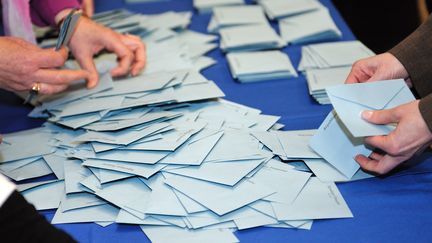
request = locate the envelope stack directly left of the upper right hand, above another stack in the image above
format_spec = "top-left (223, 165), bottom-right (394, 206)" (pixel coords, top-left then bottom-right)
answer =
top-left (298, 41), bottom-right (375, 71)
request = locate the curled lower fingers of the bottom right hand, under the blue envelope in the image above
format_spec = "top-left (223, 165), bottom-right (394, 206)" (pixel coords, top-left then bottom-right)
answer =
top-left (355, 155), bottom-right (403, 175)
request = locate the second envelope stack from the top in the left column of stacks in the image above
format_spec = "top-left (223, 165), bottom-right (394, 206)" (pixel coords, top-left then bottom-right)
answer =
top-left (207, 5), bottom-right (268, 33)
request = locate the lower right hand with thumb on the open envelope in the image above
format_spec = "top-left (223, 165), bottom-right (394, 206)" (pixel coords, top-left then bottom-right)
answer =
top-left (355, 100), bottom-right (432, 175)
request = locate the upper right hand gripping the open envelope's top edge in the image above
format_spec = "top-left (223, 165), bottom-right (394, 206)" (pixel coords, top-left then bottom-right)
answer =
top-left (345, 52), bottom-right (412, 87)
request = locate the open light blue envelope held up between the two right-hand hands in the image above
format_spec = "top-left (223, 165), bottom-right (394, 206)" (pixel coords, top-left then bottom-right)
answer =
top-left (326, 79), bottom-right (415, 137)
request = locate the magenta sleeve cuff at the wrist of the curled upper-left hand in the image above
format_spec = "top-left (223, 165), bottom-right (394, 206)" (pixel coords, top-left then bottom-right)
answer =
top-left (30, 0), bottom-right (81, 27)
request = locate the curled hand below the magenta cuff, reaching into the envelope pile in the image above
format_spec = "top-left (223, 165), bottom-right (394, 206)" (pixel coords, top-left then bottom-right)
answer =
top-left (69, 17), bottom-right (146, 88)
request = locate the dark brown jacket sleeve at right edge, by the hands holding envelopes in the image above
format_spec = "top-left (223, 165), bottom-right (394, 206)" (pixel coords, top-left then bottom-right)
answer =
top-left (389, 15), bottom-right (432, 131)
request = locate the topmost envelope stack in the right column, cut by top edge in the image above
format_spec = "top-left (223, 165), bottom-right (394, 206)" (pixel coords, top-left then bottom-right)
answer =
top-left (258, 0), bottom-right (325, 19)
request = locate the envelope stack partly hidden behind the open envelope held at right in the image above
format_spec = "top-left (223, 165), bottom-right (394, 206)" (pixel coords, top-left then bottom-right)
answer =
top-left (305, 66), bottom-right (351, 105)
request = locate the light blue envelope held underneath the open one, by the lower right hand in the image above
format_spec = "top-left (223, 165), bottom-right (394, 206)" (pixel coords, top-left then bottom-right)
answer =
top-left (309, 111), bottom-right (372, 178)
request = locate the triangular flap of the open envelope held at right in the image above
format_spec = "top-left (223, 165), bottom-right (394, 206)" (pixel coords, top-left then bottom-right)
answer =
top-left (326, 79), bottom-right (407, 110)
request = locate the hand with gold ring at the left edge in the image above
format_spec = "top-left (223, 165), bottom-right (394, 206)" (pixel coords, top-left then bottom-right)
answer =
top-left (0, 37), bottom-right (88, 94)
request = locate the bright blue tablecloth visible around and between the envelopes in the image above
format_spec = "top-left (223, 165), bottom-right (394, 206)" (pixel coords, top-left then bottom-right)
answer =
top-left (0, 0), bottom-right (432, 243)
